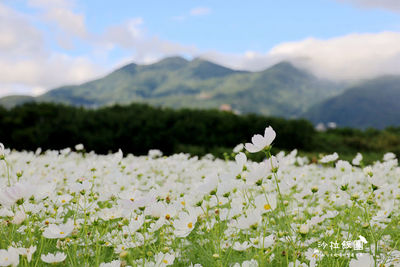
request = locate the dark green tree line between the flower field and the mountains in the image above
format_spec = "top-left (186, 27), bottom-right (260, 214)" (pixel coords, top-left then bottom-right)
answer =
top-left (0, 103), bottom-right (400, 159)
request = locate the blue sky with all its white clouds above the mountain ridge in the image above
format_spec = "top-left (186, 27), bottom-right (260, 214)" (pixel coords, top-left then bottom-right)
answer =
top-left (0, 0), bottom-right (400, 95)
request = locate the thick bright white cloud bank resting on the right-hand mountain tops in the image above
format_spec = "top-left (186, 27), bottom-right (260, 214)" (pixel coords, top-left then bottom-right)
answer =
top-left (269, 32), bottom-right (400, 79)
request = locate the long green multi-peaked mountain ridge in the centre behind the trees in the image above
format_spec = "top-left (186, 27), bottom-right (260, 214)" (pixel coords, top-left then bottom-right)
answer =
top-left (0, 57), bottom-right (343, 117)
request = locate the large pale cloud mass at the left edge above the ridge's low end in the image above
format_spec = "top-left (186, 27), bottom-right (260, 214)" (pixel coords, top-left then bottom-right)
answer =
top-left (0, 3), bottom-right (103, 98)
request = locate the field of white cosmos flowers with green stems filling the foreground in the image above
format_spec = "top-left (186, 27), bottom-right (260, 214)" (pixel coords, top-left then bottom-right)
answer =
top-left (0, 127), bottom-right (400, 267)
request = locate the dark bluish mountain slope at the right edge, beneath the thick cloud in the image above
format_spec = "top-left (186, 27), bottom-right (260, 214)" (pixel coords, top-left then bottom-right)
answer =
top-left (304, 76), bottom-right (400, 128)
